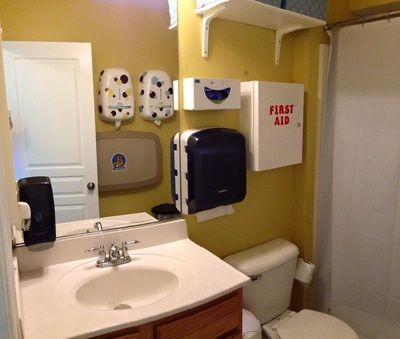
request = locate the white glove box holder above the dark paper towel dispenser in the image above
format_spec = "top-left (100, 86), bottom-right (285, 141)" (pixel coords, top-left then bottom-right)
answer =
top-left (183, 78), bottom-right (240, 111)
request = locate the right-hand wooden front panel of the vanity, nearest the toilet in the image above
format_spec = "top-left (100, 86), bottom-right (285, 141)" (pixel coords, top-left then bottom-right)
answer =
top-left (155, 293), bottom-right (242, 339)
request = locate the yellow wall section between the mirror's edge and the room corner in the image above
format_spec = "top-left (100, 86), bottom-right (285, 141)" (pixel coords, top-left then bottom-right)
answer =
top-left (178, 0), bottom-right (294, 257)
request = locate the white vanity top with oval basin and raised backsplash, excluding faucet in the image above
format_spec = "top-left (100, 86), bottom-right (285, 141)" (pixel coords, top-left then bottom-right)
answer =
top-left (15, 219), bottom-right (249, 339)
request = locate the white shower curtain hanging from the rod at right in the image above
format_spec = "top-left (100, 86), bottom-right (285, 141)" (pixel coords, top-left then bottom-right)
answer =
top-left (315, 18), bottom-right (400, 339)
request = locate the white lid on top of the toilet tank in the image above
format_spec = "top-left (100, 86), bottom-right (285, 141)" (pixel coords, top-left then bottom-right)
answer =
top-left (224, 238), bottom-right (299, 276)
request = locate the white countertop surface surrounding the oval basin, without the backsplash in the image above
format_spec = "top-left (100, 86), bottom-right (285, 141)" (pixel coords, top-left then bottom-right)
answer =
top-left (20, 221), bottom-right (249, 339)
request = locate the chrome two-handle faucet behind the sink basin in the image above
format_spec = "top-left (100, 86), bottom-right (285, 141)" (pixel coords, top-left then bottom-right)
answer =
top-left (85, 240), bottom-right (140, 268)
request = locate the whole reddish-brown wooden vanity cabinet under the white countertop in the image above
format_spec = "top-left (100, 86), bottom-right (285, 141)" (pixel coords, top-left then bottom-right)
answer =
top-left (94, 289), bottom-right (242, 339)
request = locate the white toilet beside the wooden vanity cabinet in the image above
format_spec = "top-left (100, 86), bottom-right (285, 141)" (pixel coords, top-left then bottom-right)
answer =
top-left (224, 238), bottom-right (358, 339)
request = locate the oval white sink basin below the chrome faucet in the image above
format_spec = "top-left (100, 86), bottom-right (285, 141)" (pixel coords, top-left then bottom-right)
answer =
top-left (75, 267), bottom-right (179, 310)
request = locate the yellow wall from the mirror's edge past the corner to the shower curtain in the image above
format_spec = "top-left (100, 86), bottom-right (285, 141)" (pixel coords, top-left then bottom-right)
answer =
top-left (179, 1), bottom-right (324, 266)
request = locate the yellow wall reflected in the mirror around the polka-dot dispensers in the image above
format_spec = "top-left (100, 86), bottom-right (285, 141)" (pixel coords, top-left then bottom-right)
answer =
top-left (0, 0), bottom-right (179, 244)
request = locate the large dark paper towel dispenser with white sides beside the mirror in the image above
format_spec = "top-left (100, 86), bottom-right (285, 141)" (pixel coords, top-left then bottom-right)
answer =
top-left (173, 128), bottom-right (246, 214)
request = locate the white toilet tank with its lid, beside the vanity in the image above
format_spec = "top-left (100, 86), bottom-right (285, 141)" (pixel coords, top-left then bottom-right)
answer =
top-left (224, 238), bottom-right (299, 324)
